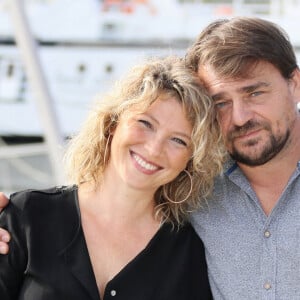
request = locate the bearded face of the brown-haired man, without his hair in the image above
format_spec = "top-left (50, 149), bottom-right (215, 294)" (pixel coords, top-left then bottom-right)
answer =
top-left (198, 61), bottom-right (299, 166)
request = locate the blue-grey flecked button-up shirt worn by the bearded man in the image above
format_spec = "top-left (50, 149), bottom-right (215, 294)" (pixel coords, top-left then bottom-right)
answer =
top-left (191, 162), bottom-right (300, 300)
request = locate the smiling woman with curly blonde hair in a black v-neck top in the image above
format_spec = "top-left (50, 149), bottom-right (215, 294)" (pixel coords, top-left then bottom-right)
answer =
top-left (0, 57), bottom-right (223, 300)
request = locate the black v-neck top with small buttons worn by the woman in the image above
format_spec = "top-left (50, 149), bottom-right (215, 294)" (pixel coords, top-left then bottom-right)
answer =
top-left (0, 186), bottom-right (212, 300)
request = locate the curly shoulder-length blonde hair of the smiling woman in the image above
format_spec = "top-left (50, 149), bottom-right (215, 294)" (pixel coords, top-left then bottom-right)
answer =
top-left (65, 56), bottom-right (226, 224)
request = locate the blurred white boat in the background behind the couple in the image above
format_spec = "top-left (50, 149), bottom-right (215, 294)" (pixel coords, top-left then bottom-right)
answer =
top-left (0, 0), bottom-right (300, 136)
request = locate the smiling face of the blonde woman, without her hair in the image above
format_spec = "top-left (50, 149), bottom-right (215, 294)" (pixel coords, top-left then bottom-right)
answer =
top-left (106, 97), bottom-right (192, 192)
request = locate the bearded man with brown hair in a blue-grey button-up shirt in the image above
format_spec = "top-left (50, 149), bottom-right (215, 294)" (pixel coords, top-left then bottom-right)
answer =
top-left (0, 17), bottom-right (300, 300)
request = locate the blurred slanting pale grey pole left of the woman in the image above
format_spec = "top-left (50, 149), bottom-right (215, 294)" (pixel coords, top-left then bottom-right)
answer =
top-left (8, 0), bottom-right (64, 184)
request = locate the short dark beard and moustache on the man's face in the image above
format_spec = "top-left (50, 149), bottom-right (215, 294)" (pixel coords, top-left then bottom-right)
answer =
top-left (228, 121), bottom-right (290, 167)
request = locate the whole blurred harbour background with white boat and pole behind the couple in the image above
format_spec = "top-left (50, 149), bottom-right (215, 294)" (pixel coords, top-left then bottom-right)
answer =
top-left (0, 0), bottom-right (300, 194)
